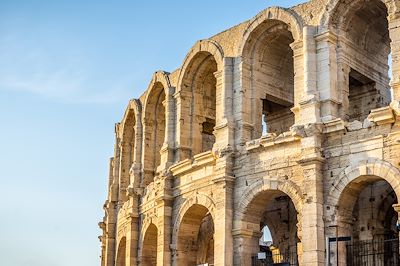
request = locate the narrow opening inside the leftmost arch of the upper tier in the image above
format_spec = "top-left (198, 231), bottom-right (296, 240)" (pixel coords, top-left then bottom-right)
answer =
top-left (119, 107), bottom-right (136, 202)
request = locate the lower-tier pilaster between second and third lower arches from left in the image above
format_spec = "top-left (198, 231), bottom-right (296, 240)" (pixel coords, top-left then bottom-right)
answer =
top-left (156, 176), bottom-right (173, 266)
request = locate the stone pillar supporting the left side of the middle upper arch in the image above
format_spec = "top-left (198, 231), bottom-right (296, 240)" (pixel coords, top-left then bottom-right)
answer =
top-left (174, 90), bottom-right (193, 161)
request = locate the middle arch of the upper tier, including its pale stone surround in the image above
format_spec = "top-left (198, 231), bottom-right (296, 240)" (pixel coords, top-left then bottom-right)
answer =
top-left (174, 40), bottom-right (224, 161)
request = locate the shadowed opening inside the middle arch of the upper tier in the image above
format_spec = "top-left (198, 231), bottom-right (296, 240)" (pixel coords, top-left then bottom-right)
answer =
top-left (181, 52), bottom-right (218, 156)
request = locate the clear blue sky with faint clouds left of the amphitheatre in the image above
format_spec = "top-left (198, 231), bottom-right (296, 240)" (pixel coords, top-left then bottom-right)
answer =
top-left (0, 0), bottom-right (301, 266)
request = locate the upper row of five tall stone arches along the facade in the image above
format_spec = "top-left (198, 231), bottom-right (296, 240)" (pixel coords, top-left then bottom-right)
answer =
top-left (115, 0), bottom-right (392, 200)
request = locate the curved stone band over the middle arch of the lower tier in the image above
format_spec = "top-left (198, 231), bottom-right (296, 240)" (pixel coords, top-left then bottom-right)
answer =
top-left (172, 194), bottom-right (215, 246)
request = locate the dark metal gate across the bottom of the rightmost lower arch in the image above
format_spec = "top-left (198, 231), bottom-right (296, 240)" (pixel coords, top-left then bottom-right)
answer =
top-left (346, 239), bottom-right (400, 266)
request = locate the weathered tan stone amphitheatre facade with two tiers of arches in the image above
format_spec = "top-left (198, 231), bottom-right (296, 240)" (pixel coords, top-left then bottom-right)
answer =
top-left (99, 0), bottom-right (400, 266)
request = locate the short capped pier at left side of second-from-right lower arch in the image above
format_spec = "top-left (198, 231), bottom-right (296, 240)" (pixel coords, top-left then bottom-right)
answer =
top-left (231, 229), bottom-right (262, 266)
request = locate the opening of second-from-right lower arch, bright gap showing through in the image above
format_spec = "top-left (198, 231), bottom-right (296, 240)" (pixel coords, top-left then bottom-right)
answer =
top-left (234, 190), bottom-right (300, 265)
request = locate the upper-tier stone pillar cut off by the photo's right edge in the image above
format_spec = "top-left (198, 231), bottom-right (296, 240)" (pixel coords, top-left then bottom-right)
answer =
top-left (388, 8), bottom-right (400, 104)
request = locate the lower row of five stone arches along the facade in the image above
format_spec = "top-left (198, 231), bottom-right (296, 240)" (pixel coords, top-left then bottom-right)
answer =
top-left (117, 160), bottom-right (400, 266)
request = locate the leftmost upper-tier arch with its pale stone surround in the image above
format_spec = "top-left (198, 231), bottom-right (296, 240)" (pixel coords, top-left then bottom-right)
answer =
top-left (118, 99), bottom-right (142, 201)
